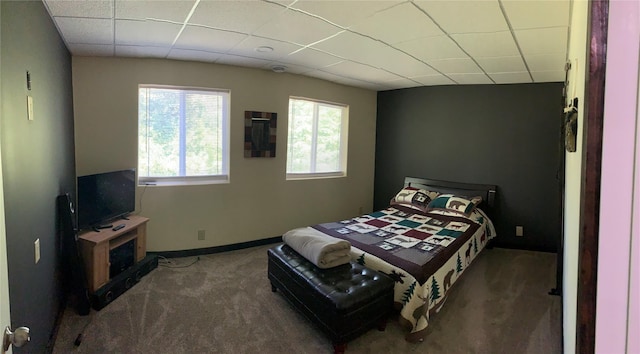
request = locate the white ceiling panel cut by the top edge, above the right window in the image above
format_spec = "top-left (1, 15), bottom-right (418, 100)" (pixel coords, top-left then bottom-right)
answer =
top-left (291, 0), bottom-right (402, 28)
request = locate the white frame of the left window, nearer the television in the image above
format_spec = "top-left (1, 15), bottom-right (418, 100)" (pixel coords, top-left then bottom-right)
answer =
top-left (137, 84), bottom-right (231, 186)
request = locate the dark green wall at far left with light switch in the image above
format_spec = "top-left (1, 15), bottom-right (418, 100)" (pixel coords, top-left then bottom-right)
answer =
top-left (0, 1), bottom-right (75, 353)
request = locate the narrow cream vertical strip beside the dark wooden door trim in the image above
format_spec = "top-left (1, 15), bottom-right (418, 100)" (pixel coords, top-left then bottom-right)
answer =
top-left (562, 0), bottom-right (589, 354)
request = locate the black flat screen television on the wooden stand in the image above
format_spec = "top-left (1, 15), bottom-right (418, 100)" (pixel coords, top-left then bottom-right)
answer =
top-left (77, 169), bottom-right (136, 229)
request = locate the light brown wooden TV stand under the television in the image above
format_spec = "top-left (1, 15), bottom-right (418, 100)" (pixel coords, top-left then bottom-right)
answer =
top-left (78, 215), bottom-right (149, 293)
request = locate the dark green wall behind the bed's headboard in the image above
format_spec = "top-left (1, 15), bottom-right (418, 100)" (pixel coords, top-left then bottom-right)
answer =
top-left (374, 83), bottom-right (562, 251)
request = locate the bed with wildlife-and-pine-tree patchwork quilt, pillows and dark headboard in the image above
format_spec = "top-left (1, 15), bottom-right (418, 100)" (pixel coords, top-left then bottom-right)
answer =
top-left (283, 177), bottom-right (496, 342)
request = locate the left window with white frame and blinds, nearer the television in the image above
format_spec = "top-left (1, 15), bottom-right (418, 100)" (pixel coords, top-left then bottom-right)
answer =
top-left (138, 85), bottom-right (229, 184)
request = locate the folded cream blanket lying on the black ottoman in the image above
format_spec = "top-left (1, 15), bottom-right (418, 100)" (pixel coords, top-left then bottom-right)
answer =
top-left (282, 227), bottom-right (351, 268)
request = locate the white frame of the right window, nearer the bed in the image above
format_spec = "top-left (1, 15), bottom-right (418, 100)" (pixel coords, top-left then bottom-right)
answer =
top-left (285, 96), bottom-right (349, 180)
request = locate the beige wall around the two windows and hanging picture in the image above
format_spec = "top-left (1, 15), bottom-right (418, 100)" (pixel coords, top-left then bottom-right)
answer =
top-left (73, 57), bottom-right (377, 251)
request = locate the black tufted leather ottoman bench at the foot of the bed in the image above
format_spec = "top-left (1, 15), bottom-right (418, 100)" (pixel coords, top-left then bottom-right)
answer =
top-left (267, 244), bottom-right (394, 353)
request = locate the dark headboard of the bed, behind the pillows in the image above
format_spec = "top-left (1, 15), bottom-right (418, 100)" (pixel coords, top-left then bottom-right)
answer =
top-left (404, 177), bottom-right (497, 211)
